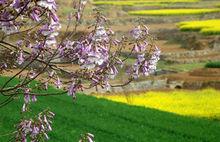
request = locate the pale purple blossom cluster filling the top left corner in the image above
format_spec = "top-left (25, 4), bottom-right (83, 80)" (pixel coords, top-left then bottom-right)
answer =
top-left (0, 0), bottom-right (60, 46)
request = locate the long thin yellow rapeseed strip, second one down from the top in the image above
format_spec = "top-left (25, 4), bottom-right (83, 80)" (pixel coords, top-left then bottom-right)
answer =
top-left (128, 8), bottom-right (220, 16)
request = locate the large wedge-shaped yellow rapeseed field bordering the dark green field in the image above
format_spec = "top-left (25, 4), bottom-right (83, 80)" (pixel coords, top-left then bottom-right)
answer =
top-left (97, 89), bottom-right (220, 118)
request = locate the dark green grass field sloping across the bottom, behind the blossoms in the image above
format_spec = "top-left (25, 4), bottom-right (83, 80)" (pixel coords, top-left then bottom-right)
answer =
top-left (0, 78), bottom-right (220, 142)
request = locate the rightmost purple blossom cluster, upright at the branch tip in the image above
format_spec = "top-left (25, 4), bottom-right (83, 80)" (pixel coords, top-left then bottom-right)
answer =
top-left (128, 25), bottom-right (160, 79)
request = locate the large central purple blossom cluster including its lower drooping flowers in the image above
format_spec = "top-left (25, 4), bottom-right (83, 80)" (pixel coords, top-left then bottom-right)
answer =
top-left (59, 17), bottom-right (123, 91)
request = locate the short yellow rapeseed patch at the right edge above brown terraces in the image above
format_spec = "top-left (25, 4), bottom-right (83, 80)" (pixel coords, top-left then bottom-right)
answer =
top-left (177, 19), bottom-right (220, 34)
